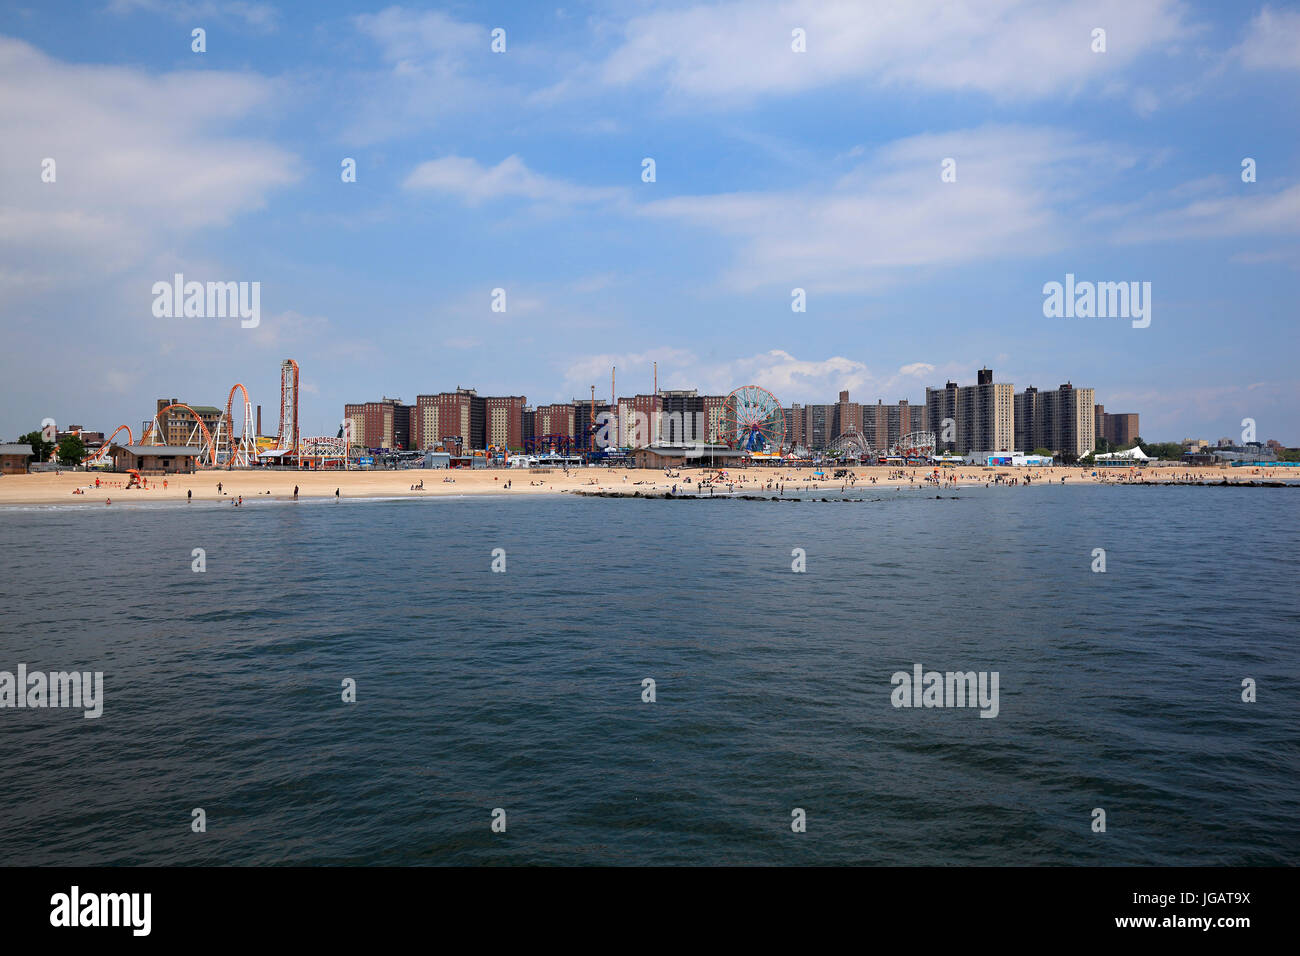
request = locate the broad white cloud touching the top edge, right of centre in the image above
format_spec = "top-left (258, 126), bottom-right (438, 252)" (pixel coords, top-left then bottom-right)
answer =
top-left (599, 0), bottom-right (1191, 100)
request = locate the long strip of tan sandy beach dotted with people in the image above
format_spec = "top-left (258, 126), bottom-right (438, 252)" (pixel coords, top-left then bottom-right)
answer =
top-left (0, 466), bottom-right (1300, 506)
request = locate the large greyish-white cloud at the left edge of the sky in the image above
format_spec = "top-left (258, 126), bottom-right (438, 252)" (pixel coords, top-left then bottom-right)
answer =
top-left (0, 38), bottom-right (299, 297)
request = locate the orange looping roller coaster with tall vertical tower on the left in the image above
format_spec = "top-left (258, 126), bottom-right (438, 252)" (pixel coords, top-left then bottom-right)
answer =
top-left (82, 359), bottom-right (351, 468)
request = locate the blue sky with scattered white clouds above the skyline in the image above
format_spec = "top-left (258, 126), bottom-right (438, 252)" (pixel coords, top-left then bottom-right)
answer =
top-left (0, 0), bottom-right (1300, 445)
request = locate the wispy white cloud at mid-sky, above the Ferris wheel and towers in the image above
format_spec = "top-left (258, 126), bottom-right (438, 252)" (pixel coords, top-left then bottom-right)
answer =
top-left (640, 127), bottom-right (1134, 297)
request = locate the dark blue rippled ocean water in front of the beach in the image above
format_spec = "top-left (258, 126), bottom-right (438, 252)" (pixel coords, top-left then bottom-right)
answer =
top-left (0, 485), bottom-right (1300, 865)
